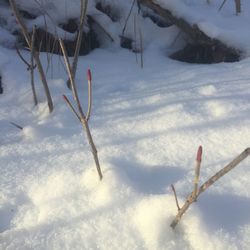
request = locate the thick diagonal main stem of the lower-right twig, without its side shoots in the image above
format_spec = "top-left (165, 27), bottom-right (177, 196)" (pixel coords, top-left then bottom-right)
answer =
top-left (170, 148), bottom-right (250, 229)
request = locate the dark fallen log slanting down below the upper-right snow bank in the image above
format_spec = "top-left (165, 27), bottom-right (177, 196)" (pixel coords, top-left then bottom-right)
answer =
top-left (138, 0), bottom-right (241, 63)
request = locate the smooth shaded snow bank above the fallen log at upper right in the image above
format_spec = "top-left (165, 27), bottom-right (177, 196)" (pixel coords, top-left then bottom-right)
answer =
top-left (154, 0), bottom-right (250, 55)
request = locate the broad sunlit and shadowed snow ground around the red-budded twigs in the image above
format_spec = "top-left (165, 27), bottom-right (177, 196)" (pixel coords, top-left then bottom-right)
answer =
top-left (0, 0), bottom-right (250, 250)
